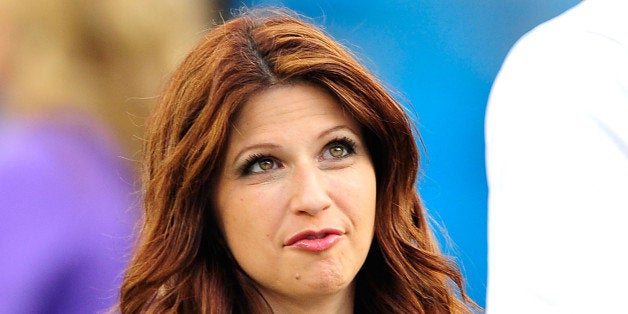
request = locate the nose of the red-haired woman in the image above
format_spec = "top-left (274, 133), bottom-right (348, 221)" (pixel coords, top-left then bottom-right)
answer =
top-left (290, 165), bottom-right (332, 215)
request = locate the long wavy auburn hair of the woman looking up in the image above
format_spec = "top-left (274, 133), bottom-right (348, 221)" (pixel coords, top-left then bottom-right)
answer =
top-left (120, 10), bottom-right (473, 313)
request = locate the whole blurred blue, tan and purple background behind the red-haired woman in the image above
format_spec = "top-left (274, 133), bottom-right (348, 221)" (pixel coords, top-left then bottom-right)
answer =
top-left (0, 0), bottom-right (578, 313)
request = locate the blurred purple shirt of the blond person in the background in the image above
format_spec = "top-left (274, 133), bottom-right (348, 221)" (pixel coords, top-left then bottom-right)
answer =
top-left (0, 114), bottom-right (138, 313)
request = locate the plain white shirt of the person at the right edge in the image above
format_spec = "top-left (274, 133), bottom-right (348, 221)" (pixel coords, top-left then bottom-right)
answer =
top-left (485, 0), bottom-right (628, 314)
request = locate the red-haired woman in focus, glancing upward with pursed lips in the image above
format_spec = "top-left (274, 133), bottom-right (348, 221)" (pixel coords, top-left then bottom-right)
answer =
top-left (120, 7), bottom-right (473, 313)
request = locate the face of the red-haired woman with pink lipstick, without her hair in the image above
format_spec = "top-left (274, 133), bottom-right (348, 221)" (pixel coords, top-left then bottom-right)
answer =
top-left (215, 84), bottom-right (376, 306)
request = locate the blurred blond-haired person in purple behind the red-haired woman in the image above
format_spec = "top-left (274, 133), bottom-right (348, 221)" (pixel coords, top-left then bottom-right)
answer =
top-left (0, 0), bottom-right (216, 313)
